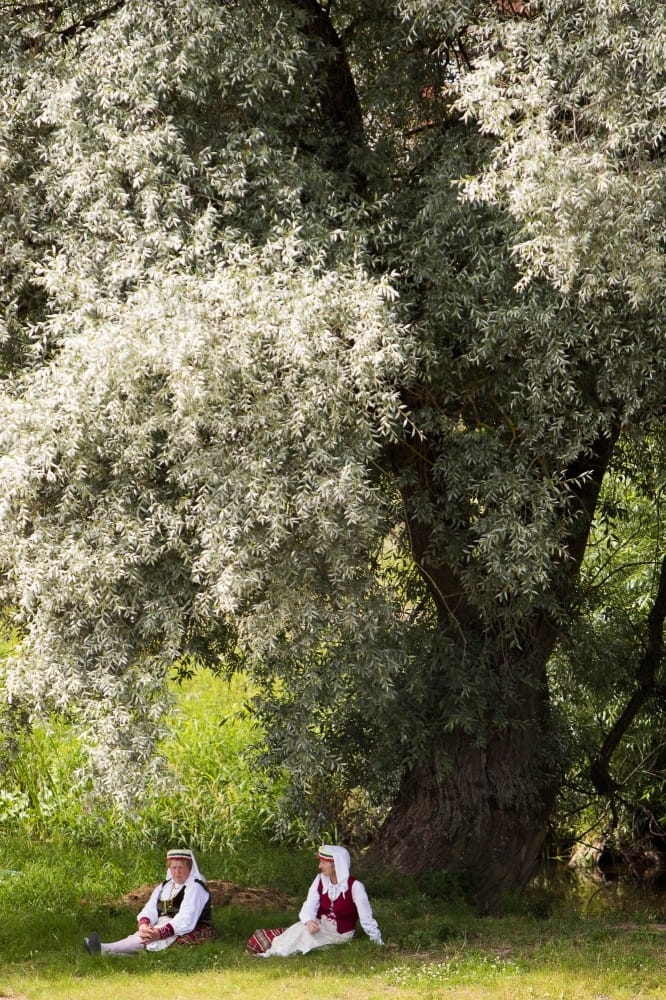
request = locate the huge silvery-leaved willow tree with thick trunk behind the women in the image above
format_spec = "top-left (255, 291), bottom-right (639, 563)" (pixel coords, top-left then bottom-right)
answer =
top-left (0, 0), bottom-right (666, 907)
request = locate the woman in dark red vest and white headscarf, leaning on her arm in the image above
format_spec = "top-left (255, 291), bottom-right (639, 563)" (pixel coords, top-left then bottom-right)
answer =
top-left (247, 844), bottom-right (383, 958)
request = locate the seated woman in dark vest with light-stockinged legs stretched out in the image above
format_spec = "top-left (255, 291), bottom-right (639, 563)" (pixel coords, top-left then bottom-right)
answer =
top-left (84, 849), bottom-right (215, 955)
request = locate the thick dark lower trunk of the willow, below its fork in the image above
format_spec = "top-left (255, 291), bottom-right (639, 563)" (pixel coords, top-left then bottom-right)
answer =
top-left (370, 644), bottom-right (559, 913)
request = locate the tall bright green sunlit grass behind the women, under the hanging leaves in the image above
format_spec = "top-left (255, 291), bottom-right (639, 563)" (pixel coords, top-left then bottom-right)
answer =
top-left (0, 671), bottom-right (281, 851)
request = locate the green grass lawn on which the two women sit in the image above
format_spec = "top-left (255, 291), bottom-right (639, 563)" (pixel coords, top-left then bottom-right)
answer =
top-left (0, 844), bottom-right (666, 1000)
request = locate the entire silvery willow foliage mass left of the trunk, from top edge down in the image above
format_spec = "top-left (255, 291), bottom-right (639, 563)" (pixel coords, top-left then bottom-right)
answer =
top-left (0, 2), bottom-right (410, 785)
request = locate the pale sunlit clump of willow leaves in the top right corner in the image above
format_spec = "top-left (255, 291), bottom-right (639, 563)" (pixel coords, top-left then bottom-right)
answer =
top-left (462, 0), bottom-right (666, 304)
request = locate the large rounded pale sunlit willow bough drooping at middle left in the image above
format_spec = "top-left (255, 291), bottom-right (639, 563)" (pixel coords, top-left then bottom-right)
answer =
top-left (0, 261), bottom-right (412, 796)
